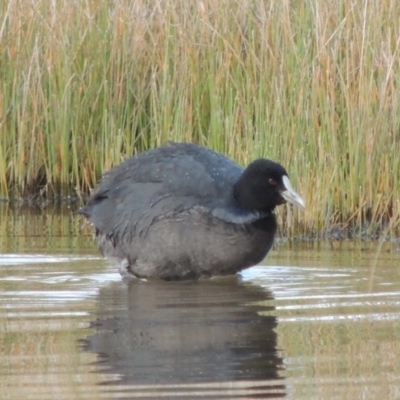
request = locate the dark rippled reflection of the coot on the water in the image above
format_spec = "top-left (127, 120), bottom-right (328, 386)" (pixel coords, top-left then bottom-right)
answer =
top-left (83, 277), bottom-right (284, 397)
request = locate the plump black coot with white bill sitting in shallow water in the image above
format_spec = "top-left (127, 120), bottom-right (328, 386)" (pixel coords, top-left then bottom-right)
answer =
top-left (78, 143), bottom-right (305, 279)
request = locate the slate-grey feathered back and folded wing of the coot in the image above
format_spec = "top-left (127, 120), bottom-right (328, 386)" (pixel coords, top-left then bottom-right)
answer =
top-left (80, 143), bottom-right (243, 239)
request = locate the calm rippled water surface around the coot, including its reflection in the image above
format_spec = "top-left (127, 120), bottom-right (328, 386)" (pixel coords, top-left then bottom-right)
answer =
top-left (0, 207), bottom-right (400, 400)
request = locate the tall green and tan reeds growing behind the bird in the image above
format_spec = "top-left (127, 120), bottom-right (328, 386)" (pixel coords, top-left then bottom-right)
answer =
top-left (0, 0), bottom-right (400, 239)
